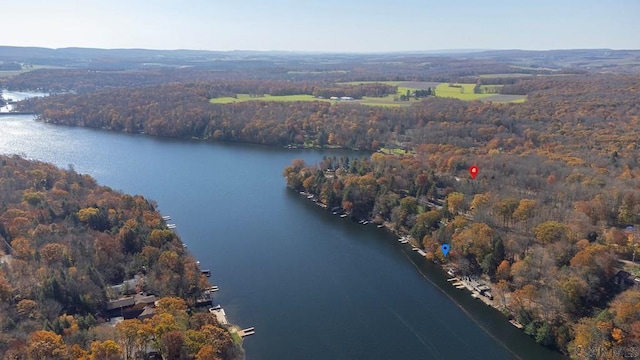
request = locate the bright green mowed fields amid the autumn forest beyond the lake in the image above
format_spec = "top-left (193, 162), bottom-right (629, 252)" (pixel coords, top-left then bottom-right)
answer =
top-left (209, 81), bottom-right (526, 106)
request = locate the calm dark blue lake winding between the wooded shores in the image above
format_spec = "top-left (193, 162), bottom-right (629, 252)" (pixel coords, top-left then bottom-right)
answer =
top-left (0, 116), bottom-right (559, 359)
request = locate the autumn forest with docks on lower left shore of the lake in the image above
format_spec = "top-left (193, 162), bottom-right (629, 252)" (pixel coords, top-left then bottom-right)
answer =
top-left (0, 155), bottom-right (242, 360)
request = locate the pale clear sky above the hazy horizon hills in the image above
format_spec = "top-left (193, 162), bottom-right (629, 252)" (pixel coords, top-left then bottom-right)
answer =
top-left (0, 0), bottom-right (640, 52)
